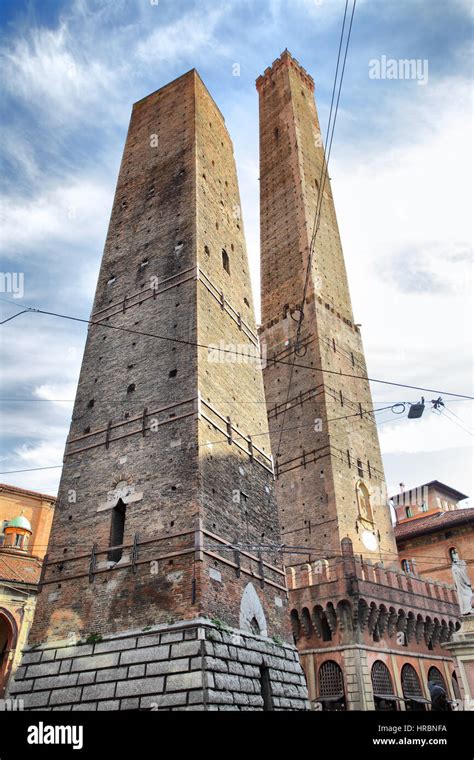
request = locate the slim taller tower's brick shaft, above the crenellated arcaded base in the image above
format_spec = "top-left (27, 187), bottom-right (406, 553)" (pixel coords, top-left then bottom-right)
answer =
top-left (257, 51), bottom-right (397, 562)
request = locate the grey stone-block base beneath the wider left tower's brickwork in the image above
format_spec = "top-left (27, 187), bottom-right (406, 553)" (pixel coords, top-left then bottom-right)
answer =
top-left (9, 618), bottom-right (309, 710)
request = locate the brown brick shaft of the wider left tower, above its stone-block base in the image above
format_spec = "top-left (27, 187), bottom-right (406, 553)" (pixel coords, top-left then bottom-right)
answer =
top-left (24, 65), bottom-right (290, 656)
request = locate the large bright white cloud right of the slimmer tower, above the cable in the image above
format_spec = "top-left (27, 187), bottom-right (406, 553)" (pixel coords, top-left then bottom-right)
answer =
top-left (331, 79), bottom-right (472, 410)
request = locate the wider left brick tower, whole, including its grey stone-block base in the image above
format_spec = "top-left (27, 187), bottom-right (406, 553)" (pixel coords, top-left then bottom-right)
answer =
top-left (11, 70), bottom-right (307, 710)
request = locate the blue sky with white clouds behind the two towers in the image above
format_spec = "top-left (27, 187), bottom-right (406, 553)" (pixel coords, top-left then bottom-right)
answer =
top-left (0, 0), bottom-right (473, 503)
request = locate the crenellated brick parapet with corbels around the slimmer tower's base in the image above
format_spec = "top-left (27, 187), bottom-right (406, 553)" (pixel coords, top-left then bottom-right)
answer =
top-left (287, 539), bottom-right (459, 646)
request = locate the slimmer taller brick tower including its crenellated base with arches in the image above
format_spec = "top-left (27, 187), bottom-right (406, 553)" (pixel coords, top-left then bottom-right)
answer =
top-left (257, 51), bottom-right (457, 710)
